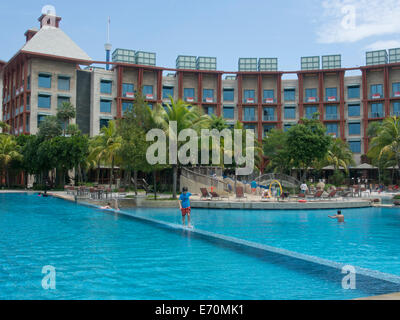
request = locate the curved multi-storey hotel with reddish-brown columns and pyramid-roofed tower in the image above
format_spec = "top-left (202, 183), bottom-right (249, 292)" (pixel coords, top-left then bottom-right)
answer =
top-left (0, 9), bottom-right (400, 163)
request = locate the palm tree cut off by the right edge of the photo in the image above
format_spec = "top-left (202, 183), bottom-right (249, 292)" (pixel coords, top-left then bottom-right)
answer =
top-left (368, 116), bottom-right (400, 175)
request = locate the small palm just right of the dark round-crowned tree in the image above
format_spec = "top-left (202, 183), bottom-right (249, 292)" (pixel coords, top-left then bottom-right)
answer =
top-left (325, 139), bottom-right (354, 173)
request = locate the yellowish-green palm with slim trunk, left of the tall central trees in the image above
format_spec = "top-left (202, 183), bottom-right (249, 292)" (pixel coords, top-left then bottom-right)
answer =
top-left (88, 121), bottom-right (122, 188)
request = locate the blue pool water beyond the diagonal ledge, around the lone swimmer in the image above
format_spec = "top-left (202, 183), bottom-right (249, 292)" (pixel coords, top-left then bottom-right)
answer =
top-left (130, 208), bottom-right (400, 276)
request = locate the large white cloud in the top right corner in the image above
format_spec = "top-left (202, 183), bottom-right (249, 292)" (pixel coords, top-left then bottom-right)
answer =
top-left (317, 0), bottom-right (400, 43)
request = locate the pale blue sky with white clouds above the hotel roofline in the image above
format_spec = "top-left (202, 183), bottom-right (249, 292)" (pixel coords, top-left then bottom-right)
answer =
top-left (0, 0), bottom-right (400, 77)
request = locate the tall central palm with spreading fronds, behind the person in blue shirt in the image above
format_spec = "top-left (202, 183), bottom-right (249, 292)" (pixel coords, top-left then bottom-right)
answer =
top-left (152, 98), bottom-right (209, 198)
